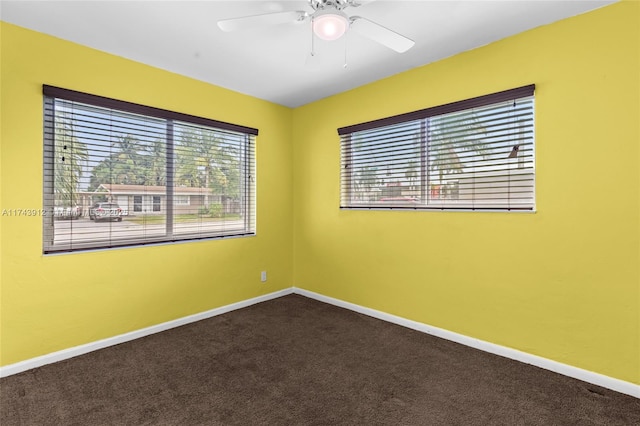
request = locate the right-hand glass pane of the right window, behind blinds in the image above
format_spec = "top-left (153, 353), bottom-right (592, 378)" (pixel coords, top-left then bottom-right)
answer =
top-left (428, 99), bottom-right (535, 208)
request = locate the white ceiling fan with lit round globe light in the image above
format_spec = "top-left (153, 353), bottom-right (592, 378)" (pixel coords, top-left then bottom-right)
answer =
top-left (218, 0), bottom-right (415, 53)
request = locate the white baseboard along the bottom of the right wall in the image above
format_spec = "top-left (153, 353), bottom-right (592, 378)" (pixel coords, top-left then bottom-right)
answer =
top-left (293, 287), bottom-right (640, 398)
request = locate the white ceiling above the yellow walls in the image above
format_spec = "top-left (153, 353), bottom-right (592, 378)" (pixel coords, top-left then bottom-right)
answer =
top-left (0, 0), bottom-right (617, 107)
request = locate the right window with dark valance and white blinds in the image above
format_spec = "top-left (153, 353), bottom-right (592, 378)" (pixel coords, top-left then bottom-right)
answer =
top-left (338, 85), bottom-right (535, 211)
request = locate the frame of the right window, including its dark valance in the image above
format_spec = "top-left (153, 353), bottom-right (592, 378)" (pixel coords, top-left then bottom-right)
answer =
top-left (337, 84), bottom-right (536, 212)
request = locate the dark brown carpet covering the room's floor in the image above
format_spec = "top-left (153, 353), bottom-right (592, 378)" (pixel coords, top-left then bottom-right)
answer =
top-left (0, 295), bottom-right (640, 426)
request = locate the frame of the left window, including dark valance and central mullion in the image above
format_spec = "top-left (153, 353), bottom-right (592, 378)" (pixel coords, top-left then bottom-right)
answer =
top-left (42, 84), bottom-right (258, 254)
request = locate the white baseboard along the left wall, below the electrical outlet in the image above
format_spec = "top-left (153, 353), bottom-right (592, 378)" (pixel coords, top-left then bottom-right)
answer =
top-left (0, 288), bottom-right (293, 377)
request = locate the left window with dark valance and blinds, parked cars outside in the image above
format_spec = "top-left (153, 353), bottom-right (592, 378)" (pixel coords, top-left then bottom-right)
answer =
top-left (43, 86), bottom-right (258, 253)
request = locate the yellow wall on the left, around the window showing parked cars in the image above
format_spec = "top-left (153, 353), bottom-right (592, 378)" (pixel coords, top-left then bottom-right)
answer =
top-left (0, 23), bottom-right (293, 365)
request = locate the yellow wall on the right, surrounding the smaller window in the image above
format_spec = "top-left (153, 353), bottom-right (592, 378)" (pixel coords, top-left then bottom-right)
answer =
top-left (293, 2), bottom-right (640, 383)
